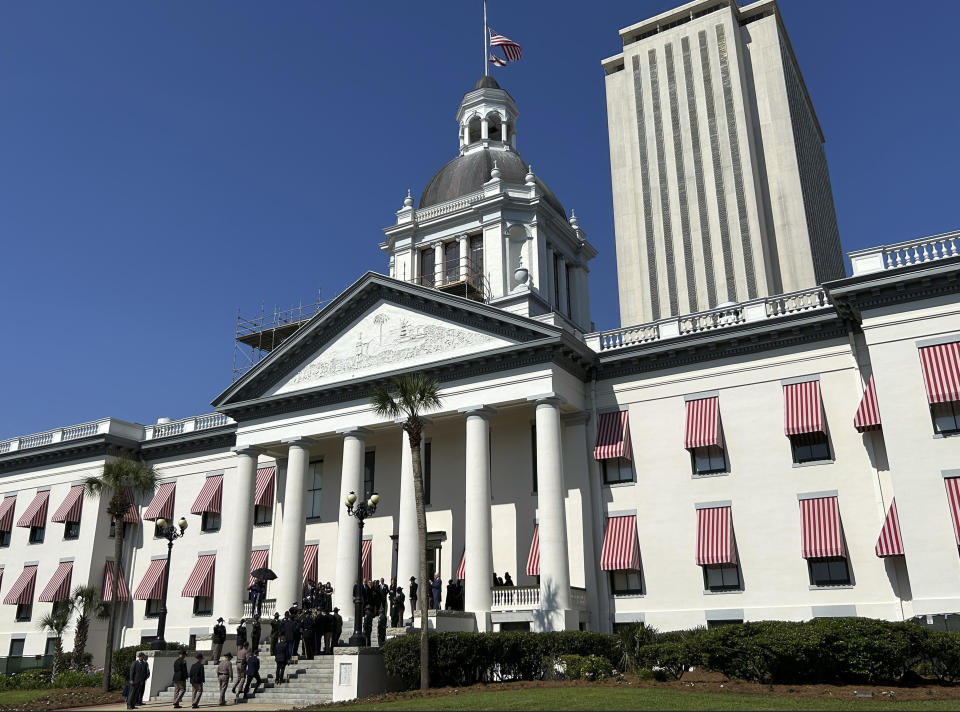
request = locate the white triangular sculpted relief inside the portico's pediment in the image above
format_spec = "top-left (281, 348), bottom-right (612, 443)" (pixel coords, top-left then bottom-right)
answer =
top-left (269, 301), bottom-right (516, 395)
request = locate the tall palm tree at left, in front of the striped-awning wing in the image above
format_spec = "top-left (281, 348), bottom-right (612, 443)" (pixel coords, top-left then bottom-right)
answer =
top-left (84, 458), bottom-right (157, 692)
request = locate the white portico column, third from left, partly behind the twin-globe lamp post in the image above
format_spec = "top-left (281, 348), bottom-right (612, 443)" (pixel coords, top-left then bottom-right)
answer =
top-left (333, 428), bottom-right (368, 616)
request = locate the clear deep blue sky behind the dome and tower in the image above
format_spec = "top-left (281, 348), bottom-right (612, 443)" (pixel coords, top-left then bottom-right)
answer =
top-left (0, 0), bottom-right (960, 439)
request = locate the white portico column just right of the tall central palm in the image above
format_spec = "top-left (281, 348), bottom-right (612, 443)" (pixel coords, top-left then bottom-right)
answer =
top-left (460, 407), bottom-right (493, 629)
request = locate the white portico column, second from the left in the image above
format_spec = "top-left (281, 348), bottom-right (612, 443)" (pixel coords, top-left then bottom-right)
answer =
top-left (274, 439), bottom-right (310, 612)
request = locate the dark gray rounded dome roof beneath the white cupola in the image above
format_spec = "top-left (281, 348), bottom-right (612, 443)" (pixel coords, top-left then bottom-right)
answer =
top-left (419, 148), bottom-right (567, 216)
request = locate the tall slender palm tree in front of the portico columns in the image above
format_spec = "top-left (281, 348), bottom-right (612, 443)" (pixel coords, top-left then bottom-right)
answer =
top-left (372, 373), bottom-right (440, 690)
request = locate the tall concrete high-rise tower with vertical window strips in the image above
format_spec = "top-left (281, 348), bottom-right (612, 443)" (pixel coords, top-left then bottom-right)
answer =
top-left (603, 0), bottom-right (844, 325)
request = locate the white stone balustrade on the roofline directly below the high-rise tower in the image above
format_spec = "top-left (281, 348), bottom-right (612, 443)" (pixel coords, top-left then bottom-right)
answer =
top-left (584, 287), bottom-right (831, 351)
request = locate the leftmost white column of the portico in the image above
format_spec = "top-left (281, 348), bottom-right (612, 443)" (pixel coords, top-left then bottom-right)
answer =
top-left (217, 447), bottom-right (260, 620)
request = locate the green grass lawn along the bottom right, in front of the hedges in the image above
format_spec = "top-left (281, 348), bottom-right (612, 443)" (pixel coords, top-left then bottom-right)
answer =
top-left (351, 685), bottom-right (958, 710)
